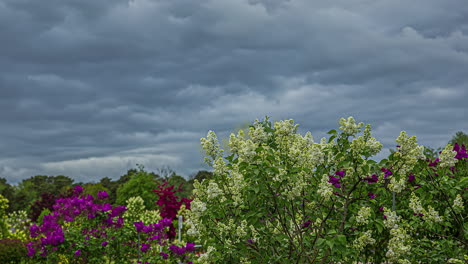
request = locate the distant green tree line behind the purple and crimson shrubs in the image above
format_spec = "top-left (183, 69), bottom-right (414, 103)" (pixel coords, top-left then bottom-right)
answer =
top-left (0, 165), bottom-right (212, 222)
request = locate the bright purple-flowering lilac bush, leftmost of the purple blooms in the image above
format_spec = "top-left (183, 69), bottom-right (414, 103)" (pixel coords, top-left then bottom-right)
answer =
top-left (27, 186), bottom-right (129, 263)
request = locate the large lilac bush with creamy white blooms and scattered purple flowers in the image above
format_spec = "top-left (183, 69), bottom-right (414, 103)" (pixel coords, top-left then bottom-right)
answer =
top-left (188, 117), bottom-right (468, 263)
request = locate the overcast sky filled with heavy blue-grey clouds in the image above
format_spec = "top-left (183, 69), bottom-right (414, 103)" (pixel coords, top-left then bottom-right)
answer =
top-left (0, 0), bottom-right (468, 183)
